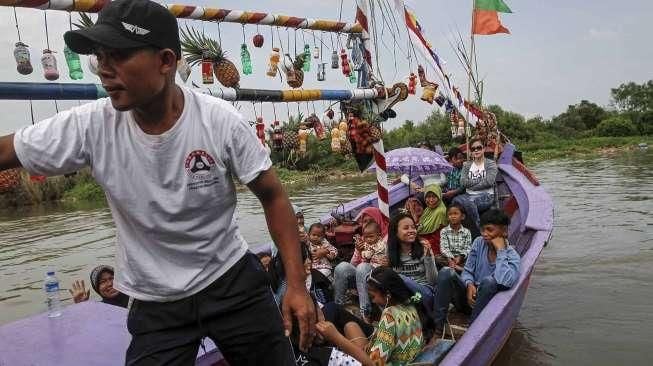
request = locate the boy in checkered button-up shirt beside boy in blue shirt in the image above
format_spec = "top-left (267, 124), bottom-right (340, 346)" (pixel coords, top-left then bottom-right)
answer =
top-left (440, 203), bottom-right (472, 273)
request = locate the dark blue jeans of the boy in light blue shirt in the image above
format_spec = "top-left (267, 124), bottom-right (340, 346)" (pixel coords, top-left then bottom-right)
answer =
top-left (435, 267), bottom-right (503, 329)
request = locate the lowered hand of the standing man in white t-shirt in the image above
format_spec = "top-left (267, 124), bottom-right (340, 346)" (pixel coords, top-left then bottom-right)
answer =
top-left (282, 287), bottom-right (315, 352)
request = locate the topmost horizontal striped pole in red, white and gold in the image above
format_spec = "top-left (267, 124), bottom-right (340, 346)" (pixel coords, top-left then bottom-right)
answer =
top-left (0, 0), bottom-right (362, 33)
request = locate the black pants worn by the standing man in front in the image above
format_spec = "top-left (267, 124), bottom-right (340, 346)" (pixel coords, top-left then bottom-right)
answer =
top-left (126, 253), bottom-right (295, 366)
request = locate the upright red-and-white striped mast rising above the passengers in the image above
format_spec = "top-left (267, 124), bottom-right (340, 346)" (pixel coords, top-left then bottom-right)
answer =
top-left (356, 0), bottom-right (390, 220)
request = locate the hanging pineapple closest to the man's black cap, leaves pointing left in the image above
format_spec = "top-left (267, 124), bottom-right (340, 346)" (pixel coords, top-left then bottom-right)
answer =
top-left (181, 26), bottom-right (240, 88)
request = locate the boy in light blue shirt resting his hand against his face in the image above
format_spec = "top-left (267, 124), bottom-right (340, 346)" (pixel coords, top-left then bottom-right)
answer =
top-left (435, 209), bottom-right (520, 331)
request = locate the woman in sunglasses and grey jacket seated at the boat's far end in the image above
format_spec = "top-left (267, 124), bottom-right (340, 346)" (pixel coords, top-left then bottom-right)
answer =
top-left (453, 138), bottom-right (499, 233)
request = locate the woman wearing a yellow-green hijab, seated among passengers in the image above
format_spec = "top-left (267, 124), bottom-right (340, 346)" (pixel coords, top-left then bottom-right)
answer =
top-left (417, 184), bottom-right (448, 256)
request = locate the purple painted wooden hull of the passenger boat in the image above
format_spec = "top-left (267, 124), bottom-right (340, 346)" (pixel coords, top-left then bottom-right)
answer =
top-left (0, 145), bottom-right (553, 366)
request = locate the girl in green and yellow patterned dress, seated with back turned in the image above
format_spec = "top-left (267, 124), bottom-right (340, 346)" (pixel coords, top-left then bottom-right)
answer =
top-left (315, 267), bottom-right (431, 366)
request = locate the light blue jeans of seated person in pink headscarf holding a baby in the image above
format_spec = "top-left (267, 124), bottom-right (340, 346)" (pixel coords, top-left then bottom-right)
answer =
top-left (333, 262), bottom-right (372, 316)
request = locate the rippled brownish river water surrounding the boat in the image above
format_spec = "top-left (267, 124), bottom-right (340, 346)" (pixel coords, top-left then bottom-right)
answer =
top-left (0, 151), bottom-right (653, 366)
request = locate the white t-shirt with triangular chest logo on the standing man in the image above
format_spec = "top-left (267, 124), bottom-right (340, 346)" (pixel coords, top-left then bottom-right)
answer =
top-left (14, 87), bottom-right (272, 301)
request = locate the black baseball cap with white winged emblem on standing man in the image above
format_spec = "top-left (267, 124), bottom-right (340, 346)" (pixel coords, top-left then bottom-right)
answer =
top-left (64, 0), bottom-right (181, 59)
